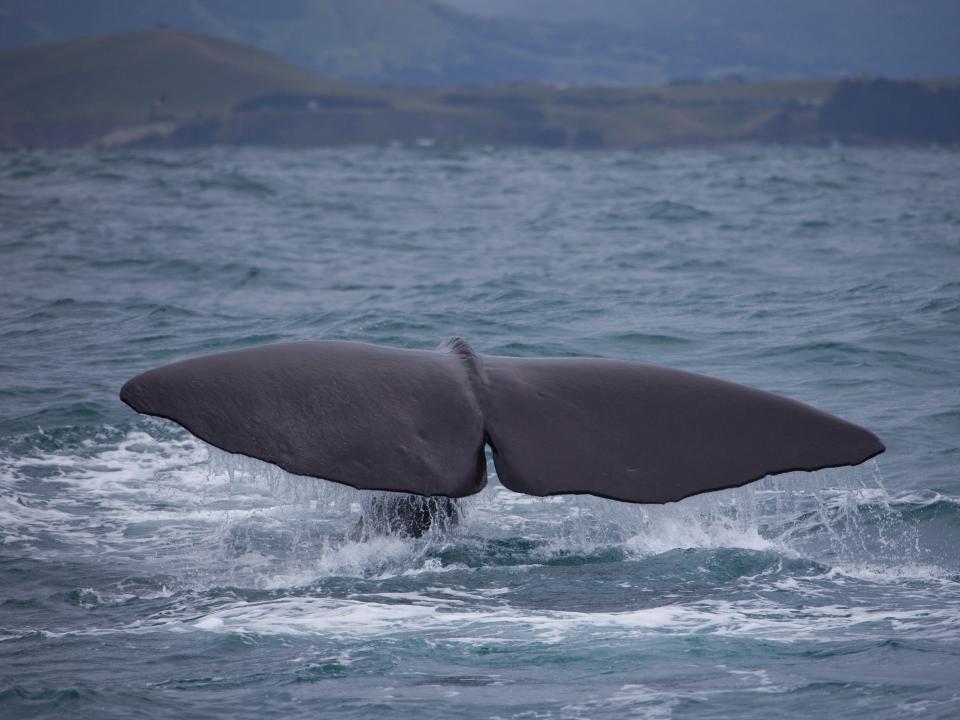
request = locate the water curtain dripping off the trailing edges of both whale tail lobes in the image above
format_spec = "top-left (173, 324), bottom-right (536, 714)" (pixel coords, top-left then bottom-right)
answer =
top-left (202, 438), bottom-right (924, 572)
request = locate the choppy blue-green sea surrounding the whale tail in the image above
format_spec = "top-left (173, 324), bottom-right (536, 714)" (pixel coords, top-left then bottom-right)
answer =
top-left (0, 147), bottom-right (960, 720)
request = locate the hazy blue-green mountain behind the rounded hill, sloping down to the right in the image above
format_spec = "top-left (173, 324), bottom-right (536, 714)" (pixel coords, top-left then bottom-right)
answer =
top-left (0, 0), bottom-right (664, 85)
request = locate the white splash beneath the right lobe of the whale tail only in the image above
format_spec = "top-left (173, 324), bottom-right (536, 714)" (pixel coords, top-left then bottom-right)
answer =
top-left (460, 462), bottom-right (943, 576)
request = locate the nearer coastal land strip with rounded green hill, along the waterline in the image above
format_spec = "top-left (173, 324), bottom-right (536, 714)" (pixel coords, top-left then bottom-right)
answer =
top-left (0, 29), bottom-right (955, 148)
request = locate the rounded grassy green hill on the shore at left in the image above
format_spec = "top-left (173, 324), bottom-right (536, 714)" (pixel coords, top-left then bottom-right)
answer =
top-left (0, 30), bottom-right (362, 121)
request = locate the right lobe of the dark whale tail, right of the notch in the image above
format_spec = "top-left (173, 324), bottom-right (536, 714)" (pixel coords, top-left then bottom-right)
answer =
top-left (484, 357), bottom-right (884, 503)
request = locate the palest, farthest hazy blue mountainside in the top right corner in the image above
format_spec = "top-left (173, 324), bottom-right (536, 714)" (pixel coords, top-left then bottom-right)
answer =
top-left (440, 0), bottom-right (960, 78)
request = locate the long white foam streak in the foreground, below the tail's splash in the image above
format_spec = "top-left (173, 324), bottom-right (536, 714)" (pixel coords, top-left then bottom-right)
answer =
top-left (172, 593), bottom-right (960, 644)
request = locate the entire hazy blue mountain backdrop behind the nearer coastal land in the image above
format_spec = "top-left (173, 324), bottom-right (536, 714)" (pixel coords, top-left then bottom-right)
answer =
top-left (0, 0), bottom-right (960, 85)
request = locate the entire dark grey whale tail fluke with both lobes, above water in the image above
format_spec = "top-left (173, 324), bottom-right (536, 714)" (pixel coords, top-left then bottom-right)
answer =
top-left (120, 338), bottom-right (884, 503)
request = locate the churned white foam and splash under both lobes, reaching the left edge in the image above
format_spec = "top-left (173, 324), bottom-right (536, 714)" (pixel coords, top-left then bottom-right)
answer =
top-left (0, 431), bottom-right (952, 589)
